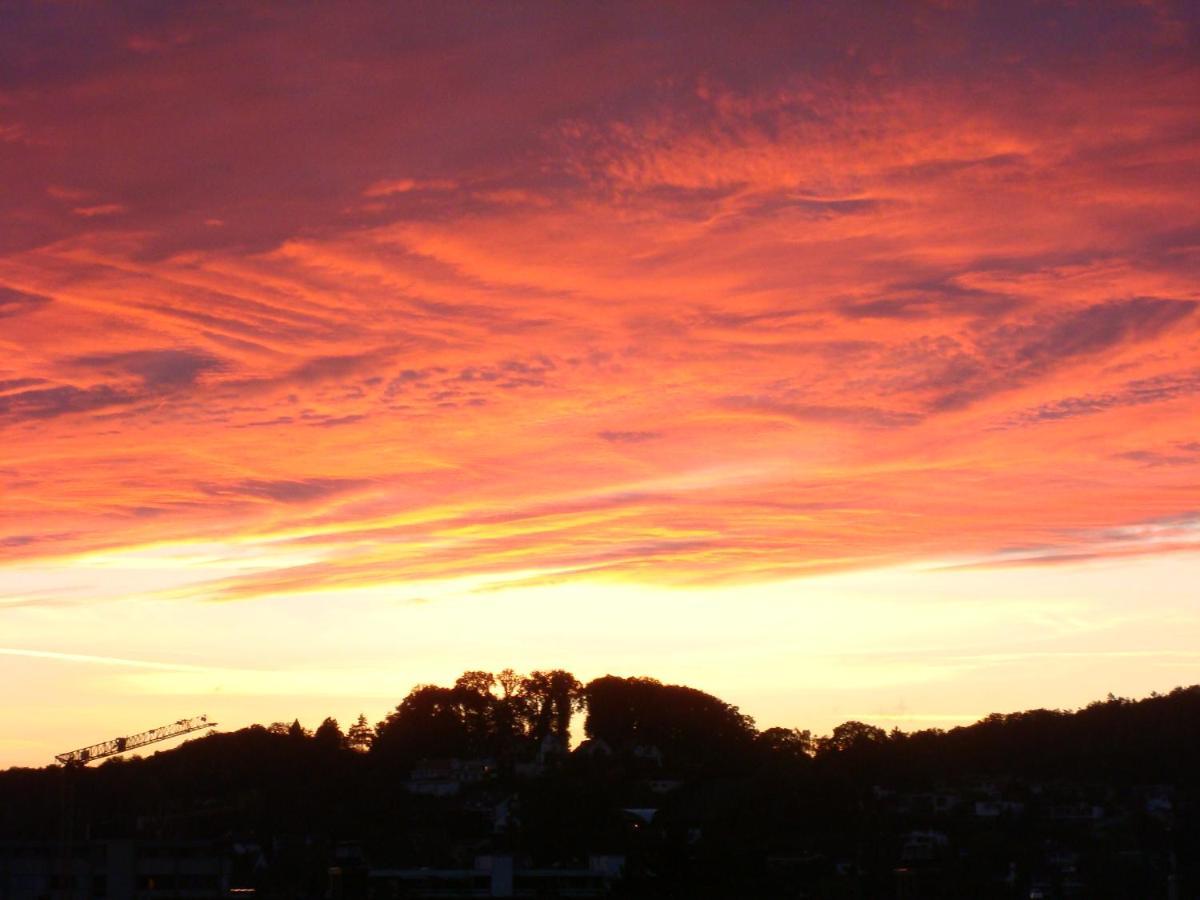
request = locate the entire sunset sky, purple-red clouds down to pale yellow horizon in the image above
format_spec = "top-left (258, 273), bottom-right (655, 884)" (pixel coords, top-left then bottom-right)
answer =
top-left (0, 0), bottom-right (1200, 766)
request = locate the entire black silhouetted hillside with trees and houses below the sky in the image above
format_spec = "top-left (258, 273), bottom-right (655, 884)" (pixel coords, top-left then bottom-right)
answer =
top-left (0, 671), bottom-right (1200, 900)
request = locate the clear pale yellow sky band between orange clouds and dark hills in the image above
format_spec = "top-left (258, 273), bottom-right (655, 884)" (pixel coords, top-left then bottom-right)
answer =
top-left (0, 556), bottom-right (1200, 766)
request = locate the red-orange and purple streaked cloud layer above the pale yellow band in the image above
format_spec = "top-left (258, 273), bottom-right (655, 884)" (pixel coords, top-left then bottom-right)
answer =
top-left (0, 4), bottom-right (1200, 607)
